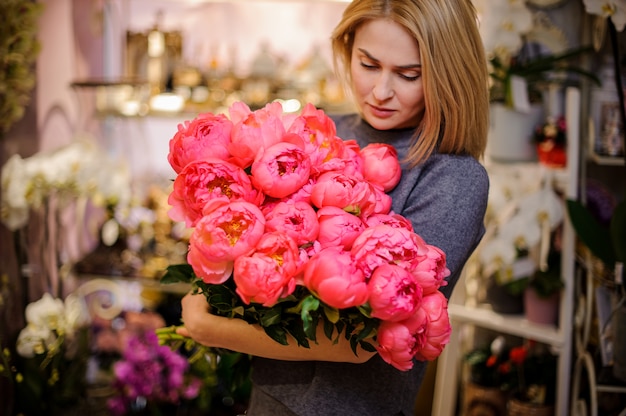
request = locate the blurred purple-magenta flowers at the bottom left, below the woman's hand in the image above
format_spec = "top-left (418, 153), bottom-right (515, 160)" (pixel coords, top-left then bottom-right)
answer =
top-left (107, 332), bottom-right (202, 415)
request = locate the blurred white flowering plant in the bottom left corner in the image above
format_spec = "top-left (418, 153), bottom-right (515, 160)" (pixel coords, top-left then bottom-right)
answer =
top-left (0, 293), bottom-right (90, 414)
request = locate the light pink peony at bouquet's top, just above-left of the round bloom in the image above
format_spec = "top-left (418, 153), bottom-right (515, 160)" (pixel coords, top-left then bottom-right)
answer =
top-left (228, 101), bottom-right (286, 168)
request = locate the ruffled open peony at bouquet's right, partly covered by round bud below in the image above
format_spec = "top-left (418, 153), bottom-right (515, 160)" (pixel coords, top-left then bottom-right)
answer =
top-left (351, 224), bottom-right (428, 278)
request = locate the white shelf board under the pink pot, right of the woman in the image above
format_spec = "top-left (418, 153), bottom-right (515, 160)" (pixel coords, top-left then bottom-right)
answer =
top-left (448, 304), bottom-right (564, 348)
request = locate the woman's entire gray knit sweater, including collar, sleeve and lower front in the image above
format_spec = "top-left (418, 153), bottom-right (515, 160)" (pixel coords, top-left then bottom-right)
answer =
top-left (248, 114), bottom-right (489, 416)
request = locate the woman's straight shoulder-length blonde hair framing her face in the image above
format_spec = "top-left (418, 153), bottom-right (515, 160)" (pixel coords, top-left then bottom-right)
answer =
top-left (331, 0), bottom-right (489, 165)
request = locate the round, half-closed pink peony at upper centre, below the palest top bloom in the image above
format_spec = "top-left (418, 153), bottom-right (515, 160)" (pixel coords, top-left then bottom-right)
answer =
top-left (252, 142), bottom-right (311, 198)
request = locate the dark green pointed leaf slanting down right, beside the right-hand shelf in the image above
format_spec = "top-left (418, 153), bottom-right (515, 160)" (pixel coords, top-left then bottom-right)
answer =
top-left (566, 199), bottom-right (615, 270)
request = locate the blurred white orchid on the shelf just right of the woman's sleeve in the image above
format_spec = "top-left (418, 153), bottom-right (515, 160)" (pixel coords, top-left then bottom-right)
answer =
top-left (475, 165), bottom-right (565, 298)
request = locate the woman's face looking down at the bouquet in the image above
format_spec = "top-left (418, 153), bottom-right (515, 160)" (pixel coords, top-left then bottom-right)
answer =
top-left (350, 19), bottom-right (424, 130)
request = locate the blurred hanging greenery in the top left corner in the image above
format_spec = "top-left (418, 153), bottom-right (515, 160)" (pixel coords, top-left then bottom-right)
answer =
top-left (0, 0), bottom-right (43, 134)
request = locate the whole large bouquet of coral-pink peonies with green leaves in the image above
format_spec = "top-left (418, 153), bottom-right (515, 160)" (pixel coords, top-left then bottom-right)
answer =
top-left (163, 102), bottom-right (451, 370)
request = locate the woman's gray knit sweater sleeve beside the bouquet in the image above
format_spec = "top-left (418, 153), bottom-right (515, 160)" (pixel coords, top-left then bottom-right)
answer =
top-left (400, 155), bottom-right (489, 298)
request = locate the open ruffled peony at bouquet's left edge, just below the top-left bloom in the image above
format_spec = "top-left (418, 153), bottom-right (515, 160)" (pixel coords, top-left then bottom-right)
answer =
top-left (168, 158), bottom-right (263, 227)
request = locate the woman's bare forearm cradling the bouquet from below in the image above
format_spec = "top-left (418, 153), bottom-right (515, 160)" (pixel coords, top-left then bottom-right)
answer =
top-left (177, 294), bottom-right (376, 363)
